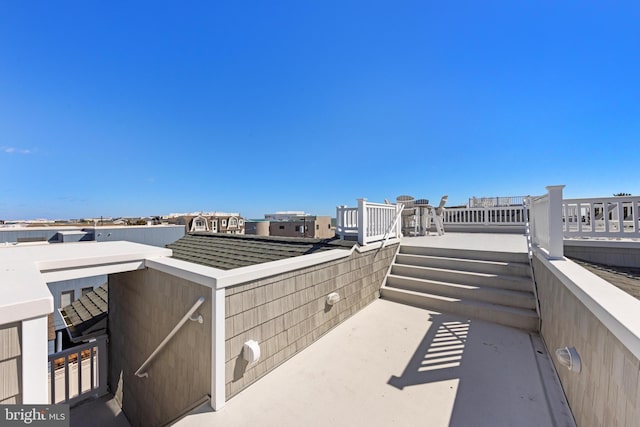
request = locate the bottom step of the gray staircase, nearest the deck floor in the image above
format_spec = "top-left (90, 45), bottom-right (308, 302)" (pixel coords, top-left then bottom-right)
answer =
top-left (380, 286), bottom-right (538, 331)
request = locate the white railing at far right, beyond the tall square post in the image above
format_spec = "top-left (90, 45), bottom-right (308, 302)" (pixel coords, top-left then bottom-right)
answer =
top-left (562, 196), bottom-right (640, 238)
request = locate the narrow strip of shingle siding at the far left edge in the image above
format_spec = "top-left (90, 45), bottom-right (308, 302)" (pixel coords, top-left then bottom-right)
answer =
top-left (0, 322), bottom-right (22, 405)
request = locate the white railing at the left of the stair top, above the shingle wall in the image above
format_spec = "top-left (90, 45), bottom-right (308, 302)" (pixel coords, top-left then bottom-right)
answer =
top-left (336, 199), bottom-right (402, 245)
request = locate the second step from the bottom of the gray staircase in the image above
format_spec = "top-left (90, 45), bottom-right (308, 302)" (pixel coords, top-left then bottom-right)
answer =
top-left (385, 274), bottom-right (536, 310)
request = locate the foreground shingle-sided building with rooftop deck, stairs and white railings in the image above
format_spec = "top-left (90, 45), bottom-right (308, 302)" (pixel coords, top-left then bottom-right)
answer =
top-left (0, 191), bottom-right (640, 426)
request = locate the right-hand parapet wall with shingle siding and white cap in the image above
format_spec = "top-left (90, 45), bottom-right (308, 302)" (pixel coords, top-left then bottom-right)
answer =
top-left (533, 256), bottom-right (640, 426)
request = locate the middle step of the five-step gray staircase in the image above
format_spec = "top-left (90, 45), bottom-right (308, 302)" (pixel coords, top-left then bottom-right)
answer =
top-left (390, 264), bottom-right (533, 292)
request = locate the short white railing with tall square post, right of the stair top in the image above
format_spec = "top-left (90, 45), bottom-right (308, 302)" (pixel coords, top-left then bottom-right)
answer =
top-left (527, 185), bottom-right (564, 259)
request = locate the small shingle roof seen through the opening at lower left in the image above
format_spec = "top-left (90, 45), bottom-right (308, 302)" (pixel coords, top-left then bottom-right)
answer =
top-left (60, 283), bottom-right (109, 342)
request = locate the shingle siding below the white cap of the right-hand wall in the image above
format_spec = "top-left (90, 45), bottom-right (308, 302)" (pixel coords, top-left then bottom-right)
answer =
top-left (534, 257), bottom-right (640, 426)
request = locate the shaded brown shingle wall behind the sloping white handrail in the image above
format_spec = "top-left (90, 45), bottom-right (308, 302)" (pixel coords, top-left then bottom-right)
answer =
top-left (109, 269), bottom-right (212, 426)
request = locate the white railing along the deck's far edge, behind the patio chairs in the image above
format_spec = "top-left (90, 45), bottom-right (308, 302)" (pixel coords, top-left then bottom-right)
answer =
top-left (443, 206), bottom-right (525, 226)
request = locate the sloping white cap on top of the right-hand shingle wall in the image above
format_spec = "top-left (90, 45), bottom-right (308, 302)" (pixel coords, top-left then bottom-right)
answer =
top-left (534, 248), bottom-right (640, 359)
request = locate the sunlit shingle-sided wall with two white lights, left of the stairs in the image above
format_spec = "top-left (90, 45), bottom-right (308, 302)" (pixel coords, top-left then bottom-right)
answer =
top-left (225, 245), bottom-right (397, 399)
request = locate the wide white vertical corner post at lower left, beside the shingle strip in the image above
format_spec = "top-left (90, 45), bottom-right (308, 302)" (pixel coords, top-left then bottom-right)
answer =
top-left (22, 316), bottom-right (49, 405)
